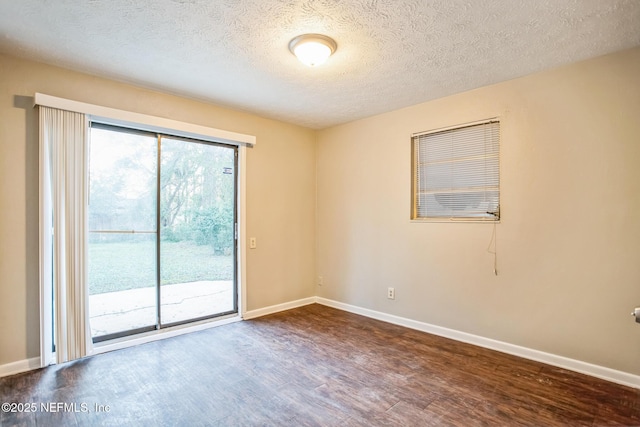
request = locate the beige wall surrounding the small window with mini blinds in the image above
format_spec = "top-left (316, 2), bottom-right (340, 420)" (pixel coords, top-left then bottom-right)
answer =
top-left (316, 48), bottom-right (640, 374)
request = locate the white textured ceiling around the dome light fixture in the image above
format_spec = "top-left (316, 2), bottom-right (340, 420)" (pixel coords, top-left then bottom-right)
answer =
top-left (0, 0), bottom-right (640, 128)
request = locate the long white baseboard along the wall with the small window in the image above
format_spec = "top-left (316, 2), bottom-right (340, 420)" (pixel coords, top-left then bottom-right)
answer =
top-left (316, 297), bottom-right (640, 389)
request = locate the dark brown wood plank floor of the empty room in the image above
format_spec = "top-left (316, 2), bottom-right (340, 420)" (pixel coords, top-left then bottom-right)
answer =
top-left (0, 304), bottom-right (640, 427)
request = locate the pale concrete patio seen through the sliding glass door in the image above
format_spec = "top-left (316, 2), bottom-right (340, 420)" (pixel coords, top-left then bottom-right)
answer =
top-left (89, 280), bottom-right (234, 337)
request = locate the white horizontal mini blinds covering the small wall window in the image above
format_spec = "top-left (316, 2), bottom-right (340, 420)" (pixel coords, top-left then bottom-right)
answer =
top-left (412, 119), bottom-right (500, 221)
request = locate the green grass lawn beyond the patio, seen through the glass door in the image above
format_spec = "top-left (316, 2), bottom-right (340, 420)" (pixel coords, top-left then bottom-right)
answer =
top-left (89, 239), bottom-right (233, 295)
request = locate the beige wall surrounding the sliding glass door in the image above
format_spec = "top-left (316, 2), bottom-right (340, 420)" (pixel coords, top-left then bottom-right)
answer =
top-left (0, 55), bottom-right (315, 365)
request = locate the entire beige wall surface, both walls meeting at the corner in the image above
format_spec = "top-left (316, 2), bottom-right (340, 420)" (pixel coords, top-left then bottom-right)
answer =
top-left (0, 48), bottom-right (640, 374)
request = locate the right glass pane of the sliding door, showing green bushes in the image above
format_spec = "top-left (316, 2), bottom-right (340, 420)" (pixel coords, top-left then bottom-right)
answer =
top-left (160, 137), bottom-right (237, 325)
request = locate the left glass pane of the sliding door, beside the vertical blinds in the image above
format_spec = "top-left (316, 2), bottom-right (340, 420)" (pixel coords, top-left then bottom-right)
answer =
top-left (88, 127), bottom-right (158, 341)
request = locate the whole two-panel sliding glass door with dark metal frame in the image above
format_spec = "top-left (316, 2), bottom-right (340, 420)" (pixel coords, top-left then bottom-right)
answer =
top-left (89, 125), bottom-right (237, 341)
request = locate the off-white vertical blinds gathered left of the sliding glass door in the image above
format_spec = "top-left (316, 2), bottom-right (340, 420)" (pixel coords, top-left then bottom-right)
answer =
top-left (39, 106), bottom-right (91, 366)
